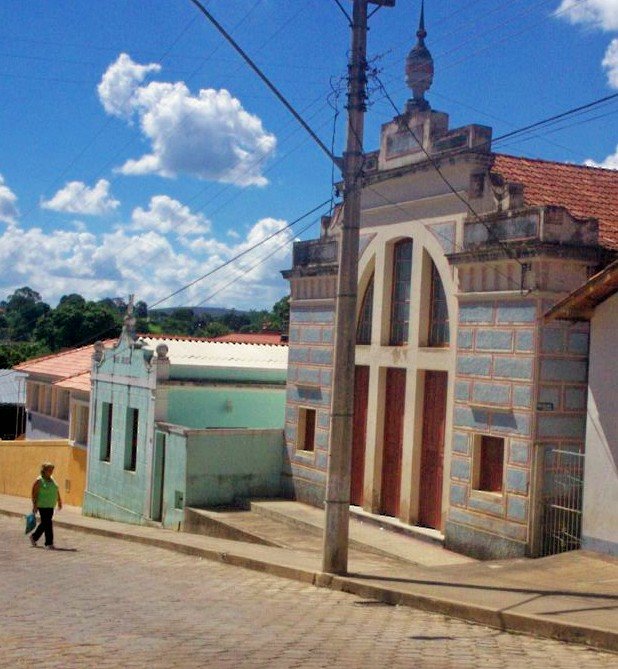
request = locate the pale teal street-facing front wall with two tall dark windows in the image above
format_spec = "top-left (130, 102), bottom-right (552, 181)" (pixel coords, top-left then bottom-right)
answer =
top-left (83, 345), bottom-right (154, 523)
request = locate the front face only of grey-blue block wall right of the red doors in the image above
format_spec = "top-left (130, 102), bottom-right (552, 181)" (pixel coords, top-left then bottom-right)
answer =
top-left (445, 299), bottom-right (540, 557)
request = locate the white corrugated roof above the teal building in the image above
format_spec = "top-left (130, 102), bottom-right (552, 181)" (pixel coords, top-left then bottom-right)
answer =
top-left (140, 337), bottom-right (288, 370)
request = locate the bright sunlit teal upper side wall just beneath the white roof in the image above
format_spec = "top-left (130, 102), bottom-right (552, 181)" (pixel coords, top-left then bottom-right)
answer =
top-left (166, 385), bottom-right (285, 429)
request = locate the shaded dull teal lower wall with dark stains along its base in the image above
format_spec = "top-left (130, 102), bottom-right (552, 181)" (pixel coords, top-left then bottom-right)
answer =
top-left (186, 429), bottom-right (283, 506)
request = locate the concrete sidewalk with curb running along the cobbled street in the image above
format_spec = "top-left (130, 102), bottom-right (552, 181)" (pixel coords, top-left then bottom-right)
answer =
top-left (0, 495), bottom-right (618, 651)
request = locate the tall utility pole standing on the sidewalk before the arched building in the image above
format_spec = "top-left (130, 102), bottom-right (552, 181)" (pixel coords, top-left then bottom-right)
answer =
top-left (322, 0), bottom-right (395, 574)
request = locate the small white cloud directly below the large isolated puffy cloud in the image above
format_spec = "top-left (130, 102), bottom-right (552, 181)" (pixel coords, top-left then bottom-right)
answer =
top-left (131, 195), bottom-right (210, 237)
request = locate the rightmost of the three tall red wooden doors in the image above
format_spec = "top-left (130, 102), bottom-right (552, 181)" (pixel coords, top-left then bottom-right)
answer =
top-left (418, 372), bottom-right (448, 529)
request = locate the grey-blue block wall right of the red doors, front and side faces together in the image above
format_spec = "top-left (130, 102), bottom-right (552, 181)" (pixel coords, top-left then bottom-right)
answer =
top-left (445, 298), bottom-right (588, 558)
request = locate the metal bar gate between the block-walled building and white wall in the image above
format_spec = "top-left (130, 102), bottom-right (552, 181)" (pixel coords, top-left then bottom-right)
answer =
top-left (540, 448), bottom-right (584, 556)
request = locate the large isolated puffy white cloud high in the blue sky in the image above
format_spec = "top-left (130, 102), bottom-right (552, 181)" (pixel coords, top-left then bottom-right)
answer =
top-left (98, 54), bottom-right (276, 186)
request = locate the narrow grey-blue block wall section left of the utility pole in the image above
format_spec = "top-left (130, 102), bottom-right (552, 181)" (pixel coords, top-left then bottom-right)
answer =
top-left (283, 300), bottom-right (335, 506)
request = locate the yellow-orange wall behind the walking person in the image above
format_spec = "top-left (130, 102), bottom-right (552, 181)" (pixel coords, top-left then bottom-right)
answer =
top-left (0, 439), bottom-right (86, 506)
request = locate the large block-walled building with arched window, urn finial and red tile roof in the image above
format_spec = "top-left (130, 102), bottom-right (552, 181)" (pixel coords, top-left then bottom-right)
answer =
top-left (283, 9), bottom-right (618, 558)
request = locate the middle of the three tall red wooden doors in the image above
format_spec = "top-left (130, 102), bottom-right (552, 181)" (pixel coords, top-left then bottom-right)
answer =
top-left (380, 367), bottom-right (406, 517)
